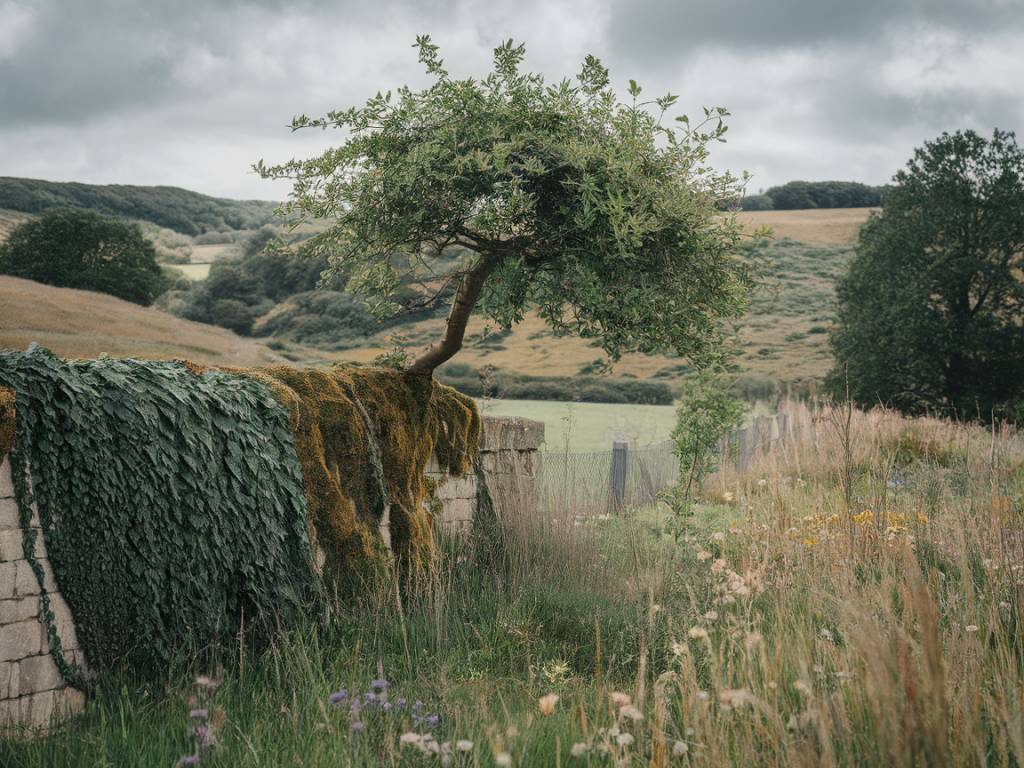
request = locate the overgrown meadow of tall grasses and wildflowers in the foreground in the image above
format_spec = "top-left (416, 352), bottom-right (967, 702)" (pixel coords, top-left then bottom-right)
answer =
top-left (0, 404), bottom-right (1024, 767)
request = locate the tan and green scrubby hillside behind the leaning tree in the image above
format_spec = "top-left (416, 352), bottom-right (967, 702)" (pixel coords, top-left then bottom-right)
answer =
top-left (292, 208), bottom-right (869, 391)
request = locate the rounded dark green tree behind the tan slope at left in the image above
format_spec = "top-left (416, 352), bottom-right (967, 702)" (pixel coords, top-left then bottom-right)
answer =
top-left (0, 209), bottom-right (166, 305)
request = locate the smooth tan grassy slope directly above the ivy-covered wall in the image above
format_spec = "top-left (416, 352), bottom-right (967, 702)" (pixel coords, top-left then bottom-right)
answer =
top-left (0, 275), bottom-right (285, 366)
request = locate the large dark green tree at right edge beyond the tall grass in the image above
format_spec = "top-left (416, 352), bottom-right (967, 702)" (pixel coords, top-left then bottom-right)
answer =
top-left (828, 130), bottom-right (1024, 419)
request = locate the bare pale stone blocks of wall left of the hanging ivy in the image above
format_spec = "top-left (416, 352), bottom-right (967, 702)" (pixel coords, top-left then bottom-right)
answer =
top-left (0, 459), bottom-right (85, 729)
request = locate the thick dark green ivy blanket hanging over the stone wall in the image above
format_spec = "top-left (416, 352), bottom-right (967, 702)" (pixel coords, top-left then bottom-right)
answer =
top-left (0, 347), bottom-right (314, 673)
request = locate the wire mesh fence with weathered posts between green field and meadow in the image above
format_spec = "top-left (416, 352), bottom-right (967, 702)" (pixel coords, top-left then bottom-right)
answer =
top-left (539, 414), bottom-right (791, 515)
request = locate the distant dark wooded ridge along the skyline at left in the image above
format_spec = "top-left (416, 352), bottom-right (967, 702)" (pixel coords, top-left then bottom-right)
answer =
top-left (0, 176), bottom-right (275, 236)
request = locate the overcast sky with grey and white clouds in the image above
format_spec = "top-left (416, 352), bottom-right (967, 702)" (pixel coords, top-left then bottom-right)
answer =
top-left (0, 0), bottom-right (1024, 199)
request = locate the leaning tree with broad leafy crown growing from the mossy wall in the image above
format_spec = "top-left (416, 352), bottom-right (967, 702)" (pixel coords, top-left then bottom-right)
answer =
top-left (256, 37), bottom-right (749, 374)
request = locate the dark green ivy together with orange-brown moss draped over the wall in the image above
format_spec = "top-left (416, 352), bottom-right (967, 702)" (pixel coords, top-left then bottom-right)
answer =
top-left (0, 347), bottom-right (480, 671)
